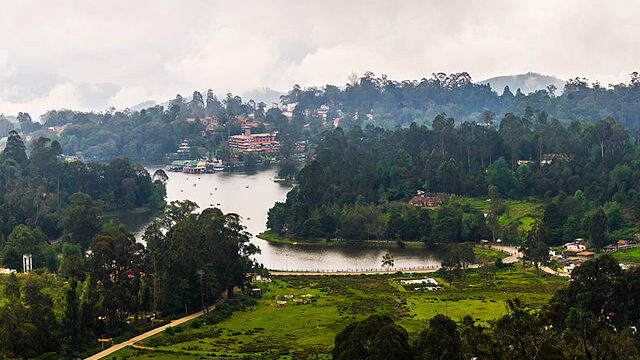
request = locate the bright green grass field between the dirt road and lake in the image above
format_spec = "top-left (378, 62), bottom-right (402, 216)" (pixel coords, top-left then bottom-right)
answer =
top-left (109, 267), bottom-right (566, 359)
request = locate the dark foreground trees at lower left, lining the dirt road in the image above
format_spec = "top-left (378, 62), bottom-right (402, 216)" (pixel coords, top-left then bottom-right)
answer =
top-left (0, 201), bottom-right (258, 358)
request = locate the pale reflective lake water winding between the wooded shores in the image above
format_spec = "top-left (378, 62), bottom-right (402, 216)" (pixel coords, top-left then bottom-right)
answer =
top-left (136, 168), bottom-right (439, 271)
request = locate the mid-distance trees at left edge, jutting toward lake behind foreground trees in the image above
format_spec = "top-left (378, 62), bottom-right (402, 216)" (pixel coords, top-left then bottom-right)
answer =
top-left (0, 131), bottom-right (166, 271)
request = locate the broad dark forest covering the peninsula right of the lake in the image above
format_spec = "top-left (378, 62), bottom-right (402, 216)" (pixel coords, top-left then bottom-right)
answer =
top-left (267, 114), bottom-right (640, 247)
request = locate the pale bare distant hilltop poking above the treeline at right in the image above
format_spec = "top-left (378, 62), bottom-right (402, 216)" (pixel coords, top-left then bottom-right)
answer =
top-left (478, 72), bottom-right (565, 94)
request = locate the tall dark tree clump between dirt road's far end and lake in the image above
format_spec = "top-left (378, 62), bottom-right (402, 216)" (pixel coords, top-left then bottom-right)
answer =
top-left (143, 200), bottom-right (259, 313)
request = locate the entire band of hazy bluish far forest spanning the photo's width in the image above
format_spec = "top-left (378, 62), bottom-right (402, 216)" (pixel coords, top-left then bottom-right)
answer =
top-left (8, 72), bottom-right (640, 161)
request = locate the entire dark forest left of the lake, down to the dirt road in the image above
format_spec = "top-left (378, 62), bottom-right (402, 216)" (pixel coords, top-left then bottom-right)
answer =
top-left (0, 131), bottom-right (258, 358)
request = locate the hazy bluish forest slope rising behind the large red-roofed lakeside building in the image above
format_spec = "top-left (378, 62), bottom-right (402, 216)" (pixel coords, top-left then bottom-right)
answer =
top-left (43, 90), bottom-right (310, 161)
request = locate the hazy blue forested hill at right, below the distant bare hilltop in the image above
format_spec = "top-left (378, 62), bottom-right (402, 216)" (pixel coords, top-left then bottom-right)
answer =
top-left (283, 72), bottom-right (640, 134)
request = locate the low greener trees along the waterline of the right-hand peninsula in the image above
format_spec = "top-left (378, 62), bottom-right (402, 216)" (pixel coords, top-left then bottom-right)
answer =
top-left (267, 196), bottom-right (490, 246)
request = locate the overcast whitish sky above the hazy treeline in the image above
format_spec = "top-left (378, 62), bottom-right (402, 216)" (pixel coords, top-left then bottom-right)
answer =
top-left (0, 0), bottom-right (640, 118)
